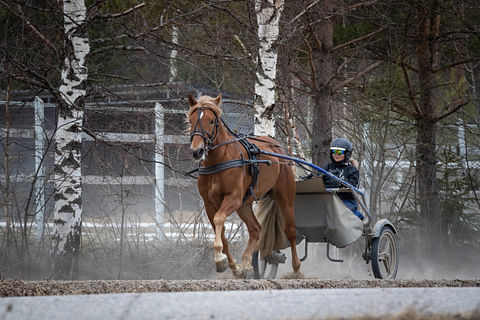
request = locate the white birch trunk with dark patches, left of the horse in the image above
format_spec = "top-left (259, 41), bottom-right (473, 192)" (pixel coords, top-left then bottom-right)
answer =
top-left (52, 0), bottom-right (90, 279)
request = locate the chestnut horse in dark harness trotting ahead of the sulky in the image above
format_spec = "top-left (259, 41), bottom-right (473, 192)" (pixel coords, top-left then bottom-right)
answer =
top-left (187, 95), bottom-right (300, 277)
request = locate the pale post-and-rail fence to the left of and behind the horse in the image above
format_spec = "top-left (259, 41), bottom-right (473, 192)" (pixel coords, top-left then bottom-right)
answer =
top-left (0, 93), bottom-right (253, 242)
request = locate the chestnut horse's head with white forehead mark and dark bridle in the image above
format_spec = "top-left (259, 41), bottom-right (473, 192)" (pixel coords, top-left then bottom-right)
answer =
top-left (187, 95), bottom-right (222, 160)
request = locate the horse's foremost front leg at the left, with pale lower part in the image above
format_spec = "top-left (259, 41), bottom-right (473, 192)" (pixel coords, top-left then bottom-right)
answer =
top-left (213, 196), bottom-right (242, 273)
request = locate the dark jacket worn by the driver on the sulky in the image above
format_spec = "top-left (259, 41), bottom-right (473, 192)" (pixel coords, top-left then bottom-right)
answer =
top-left (323, 162), bottom-right (360, 200)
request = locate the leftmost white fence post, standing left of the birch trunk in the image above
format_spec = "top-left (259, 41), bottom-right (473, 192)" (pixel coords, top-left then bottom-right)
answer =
top-left (33, 97), bottom-right (45, 244)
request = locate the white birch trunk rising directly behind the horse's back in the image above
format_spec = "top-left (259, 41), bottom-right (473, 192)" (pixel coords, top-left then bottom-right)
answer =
top-left (254, 0), bottom-right (284, 137)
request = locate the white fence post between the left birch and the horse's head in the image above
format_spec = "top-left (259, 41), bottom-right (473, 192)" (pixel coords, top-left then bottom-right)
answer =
top-left (154, 102), bottom-right (165, 240)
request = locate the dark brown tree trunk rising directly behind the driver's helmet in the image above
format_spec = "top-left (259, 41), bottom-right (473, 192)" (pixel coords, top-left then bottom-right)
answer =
top-left (312, 0), bottom-right (333, 166)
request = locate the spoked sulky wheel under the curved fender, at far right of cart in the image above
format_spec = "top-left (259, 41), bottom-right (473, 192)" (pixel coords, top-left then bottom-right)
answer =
top-left (372, 226), bottom-right (398, 279)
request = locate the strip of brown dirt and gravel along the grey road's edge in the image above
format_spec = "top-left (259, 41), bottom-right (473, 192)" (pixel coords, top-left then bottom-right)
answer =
top-left (0, 279), bottom-right (480, 297)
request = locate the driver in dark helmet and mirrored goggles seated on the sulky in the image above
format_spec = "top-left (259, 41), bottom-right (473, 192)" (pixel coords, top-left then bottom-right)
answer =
top-left (323, 138), bottom-right (363, 220)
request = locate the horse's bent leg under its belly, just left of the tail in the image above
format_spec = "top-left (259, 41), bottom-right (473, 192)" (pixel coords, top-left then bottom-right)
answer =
top-left (237, 203), bottom-right (262, 277)
